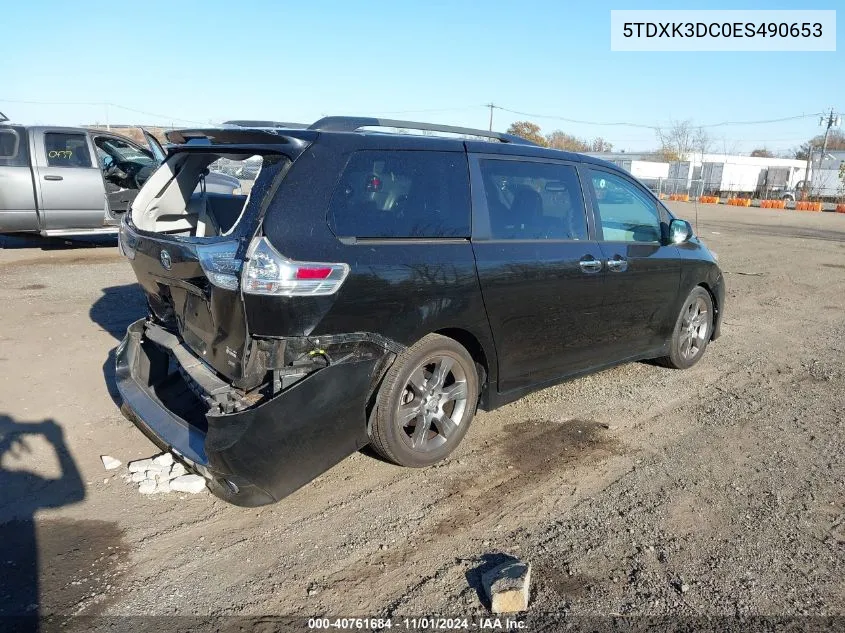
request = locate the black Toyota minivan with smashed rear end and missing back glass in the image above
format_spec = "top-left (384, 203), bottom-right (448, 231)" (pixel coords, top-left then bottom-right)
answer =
top-left (117, 117), bottom-right (725, 505)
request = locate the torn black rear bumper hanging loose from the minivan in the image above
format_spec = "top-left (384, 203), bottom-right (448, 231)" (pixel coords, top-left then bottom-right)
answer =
top-left (116, 319), bottom-right (390, 506)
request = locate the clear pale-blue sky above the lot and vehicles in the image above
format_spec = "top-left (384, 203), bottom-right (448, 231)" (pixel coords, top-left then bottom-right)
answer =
top-left (0, 0), bottom-right (845, 151)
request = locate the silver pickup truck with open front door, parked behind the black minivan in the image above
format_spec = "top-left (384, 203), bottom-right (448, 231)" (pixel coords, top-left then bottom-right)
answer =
top-left (0, 115), bottom-right (241, 236)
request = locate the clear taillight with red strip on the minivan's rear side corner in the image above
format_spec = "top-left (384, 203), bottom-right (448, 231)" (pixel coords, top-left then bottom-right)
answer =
top-left (241, 237), bottom-right (349, 297)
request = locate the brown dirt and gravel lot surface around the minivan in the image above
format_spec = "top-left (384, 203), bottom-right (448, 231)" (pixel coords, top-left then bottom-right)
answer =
top-left (0, 204), bottom-right (845, 619)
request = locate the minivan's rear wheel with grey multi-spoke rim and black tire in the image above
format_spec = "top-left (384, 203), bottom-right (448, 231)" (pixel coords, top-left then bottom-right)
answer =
top-left (370, 334), bottom-right (478, 468)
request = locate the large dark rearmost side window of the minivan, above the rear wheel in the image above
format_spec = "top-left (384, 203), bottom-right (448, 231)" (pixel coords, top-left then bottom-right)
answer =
top-left (328, 150), bottom-right (470, 238)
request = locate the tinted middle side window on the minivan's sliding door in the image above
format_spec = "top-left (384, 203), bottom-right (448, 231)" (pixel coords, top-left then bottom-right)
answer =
top-left (481, 159), bottom-right (587, 240)
